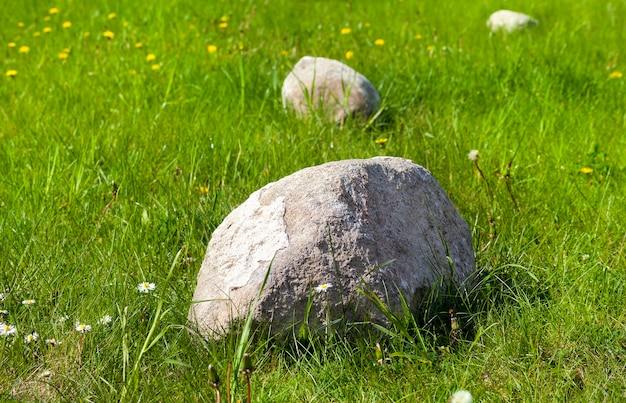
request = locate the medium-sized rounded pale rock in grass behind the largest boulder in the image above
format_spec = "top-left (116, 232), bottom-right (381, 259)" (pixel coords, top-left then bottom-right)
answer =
top-left (282, 56), bottom-right (380, 122)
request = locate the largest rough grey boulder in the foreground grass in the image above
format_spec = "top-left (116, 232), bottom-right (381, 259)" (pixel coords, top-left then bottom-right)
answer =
top-left (189, 157), bottom-right (475, 336)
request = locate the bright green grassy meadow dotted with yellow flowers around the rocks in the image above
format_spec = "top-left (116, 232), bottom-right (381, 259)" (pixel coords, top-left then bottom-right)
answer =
top-left (0, 0), bottom-right (626, 402)
